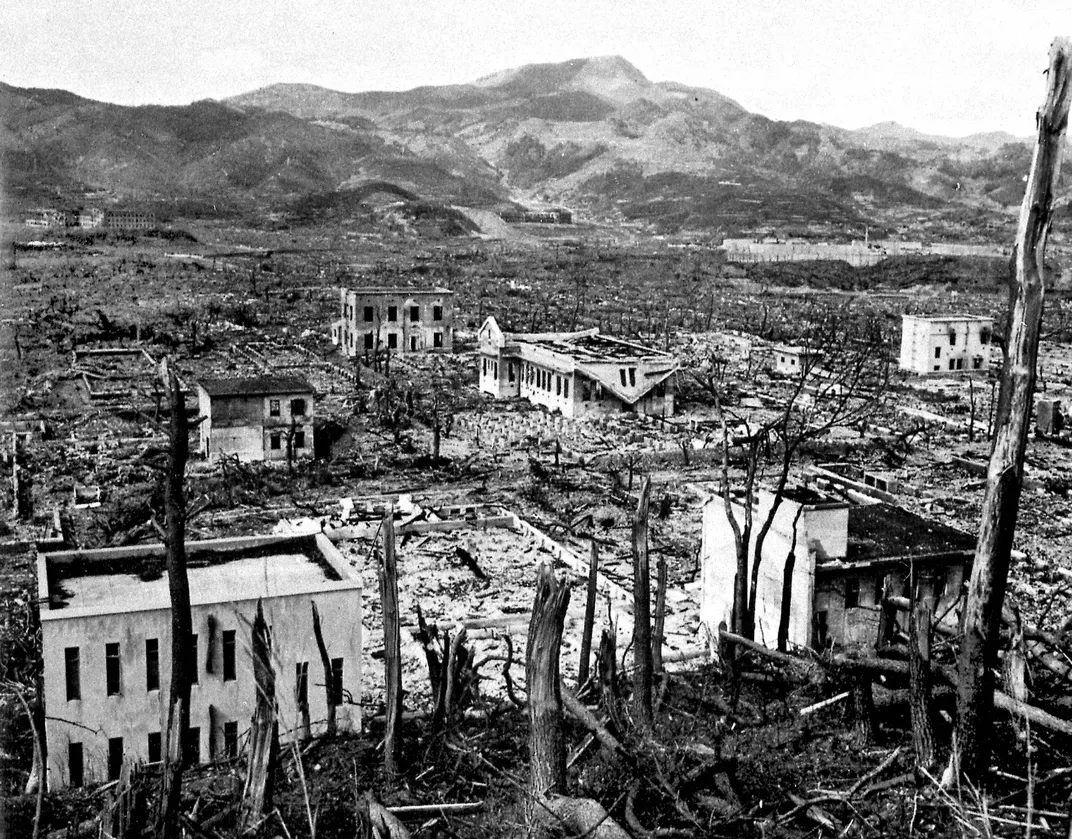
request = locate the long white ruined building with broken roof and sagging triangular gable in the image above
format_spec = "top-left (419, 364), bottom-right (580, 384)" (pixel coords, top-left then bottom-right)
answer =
top-left (477, 317), bottom-right (679, 417)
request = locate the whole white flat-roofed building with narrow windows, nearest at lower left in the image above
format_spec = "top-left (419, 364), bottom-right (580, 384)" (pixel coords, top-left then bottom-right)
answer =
top-left (38, 534), bottom-right (361, 790)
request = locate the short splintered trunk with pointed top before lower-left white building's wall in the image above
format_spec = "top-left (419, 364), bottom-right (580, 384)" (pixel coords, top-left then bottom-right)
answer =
top-left (240, 600), bottom-right (279, 830)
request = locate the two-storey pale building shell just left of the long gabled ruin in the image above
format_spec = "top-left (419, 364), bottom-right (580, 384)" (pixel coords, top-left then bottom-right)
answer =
top-left (331, 287), bottom-right (455, 357)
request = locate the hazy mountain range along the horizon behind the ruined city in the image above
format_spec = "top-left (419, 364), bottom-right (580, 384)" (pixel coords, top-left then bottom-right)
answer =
top-left (0, 56), bottom-right (1030, 234)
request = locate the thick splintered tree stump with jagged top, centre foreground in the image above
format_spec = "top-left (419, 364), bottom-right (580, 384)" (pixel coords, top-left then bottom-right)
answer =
top-left (525, 565), bottom-right (569, 822)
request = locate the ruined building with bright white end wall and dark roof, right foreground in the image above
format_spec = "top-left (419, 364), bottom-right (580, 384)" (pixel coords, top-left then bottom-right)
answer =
top-left (700, 489), bottom-right (976, 648)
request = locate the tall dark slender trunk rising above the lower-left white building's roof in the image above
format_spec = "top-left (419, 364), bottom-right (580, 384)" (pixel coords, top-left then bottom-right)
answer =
top-left (155, 360), bottom-right (196, 839)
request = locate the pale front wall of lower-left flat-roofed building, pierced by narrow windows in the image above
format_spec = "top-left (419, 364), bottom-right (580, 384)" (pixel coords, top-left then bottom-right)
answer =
top-left (42, 540), bottom-right (361, 790)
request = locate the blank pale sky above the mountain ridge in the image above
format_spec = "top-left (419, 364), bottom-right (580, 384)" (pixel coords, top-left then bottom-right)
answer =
top-left (0, 0), bottom-right (1072, 136)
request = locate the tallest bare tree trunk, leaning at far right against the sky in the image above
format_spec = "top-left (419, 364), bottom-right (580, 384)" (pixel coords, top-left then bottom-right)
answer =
top-left (954, 39), bottom-right (1072, 782)
